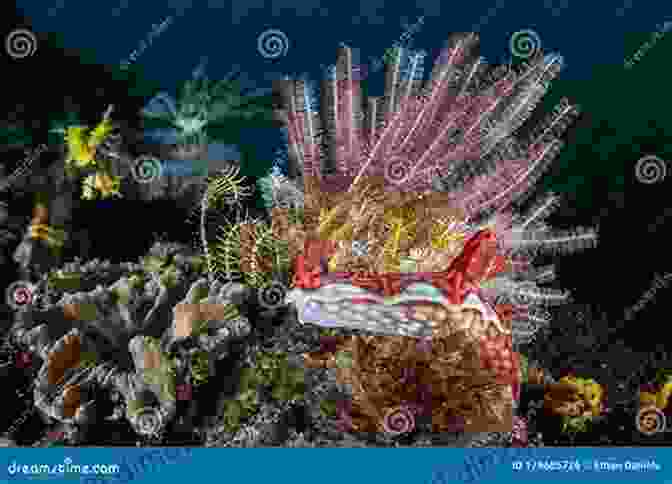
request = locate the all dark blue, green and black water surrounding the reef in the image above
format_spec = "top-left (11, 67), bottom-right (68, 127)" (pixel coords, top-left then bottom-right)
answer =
top-left (0, 0), bottom-right (672, 443)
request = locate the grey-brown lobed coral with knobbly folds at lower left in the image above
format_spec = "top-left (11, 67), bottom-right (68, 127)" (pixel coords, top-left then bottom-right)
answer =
top-left (3, 245), bottom-right (250, 436)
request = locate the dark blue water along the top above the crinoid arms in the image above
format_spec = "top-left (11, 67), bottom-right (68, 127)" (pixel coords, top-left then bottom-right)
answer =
top-left (10, 0), bottom-right (672, 170)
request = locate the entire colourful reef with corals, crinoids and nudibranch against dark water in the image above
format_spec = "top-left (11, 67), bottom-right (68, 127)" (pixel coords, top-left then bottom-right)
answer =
top-left (0, 34), bottom-right (672, 447)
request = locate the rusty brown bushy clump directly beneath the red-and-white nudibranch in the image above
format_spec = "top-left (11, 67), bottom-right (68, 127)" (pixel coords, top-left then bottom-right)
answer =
top-left (307, 335), bottom-right (511, 433)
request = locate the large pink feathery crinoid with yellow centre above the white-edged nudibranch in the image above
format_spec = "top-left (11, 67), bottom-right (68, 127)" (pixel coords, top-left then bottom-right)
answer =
top-left (272, 33), bottom-right (597, 343)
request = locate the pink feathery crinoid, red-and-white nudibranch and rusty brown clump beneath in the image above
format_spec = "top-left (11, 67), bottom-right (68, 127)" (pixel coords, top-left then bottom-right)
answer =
top-left (264, 35), bottom-right (596, 433)
